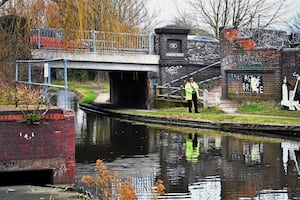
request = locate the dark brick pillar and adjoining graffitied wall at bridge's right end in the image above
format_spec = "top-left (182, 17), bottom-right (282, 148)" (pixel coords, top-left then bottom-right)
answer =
top-left (155, 26), bottom-right (220, 86)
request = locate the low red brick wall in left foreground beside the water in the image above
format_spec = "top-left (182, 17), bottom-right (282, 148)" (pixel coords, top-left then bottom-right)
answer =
top-left (0, 109), bottom-right (75, 184)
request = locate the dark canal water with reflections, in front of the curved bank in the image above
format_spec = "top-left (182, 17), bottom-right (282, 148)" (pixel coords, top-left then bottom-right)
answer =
top-left (56, 91), bottom-right (300, 200)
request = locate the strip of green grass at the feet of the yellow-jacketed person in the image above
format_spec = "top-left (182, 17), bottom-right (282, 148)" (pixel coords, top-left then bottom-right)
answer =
top-left (121, 104), bottom-right (300, 124)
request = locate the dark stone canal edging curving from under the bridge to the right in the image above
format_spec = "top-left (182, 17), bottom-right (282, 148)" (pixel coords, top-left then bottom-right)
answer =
top-left (79, 103), bottom-right (300, 137)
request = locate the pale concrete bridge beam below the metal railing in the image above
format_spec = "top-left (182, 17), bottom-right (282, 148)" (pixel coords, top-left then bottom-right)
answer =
top-left (31, 49), bottom-right (159, 72)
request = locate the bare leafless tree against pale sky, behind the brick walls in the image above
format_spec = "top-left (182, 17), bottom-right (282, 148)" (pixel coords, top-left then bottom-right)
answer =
top-left (186, 0), bottom-right (288, 38)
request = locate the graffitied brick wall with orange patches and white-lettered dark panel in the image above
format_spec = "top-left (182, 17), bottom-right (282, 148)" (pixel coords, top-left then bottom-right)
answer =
top-left (221, 28), bottom-right (283, 101)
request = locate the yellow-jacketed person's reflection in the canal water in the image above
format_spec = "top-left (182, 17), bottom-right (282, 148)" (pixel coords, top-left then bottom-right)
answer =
top-left (185, 133), bottom-right (199, 162)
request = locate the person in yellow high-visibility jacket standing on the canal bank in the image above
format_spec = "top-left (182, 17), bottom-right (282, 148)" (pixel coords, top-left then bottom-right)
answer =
top-left (184, 76), bottom-right (199, 113)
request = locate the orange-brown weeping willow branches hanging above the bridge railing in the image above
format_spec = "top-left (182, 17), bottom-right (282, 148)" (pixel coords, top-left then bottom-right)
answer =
top-left (27, 0), bottom-right (149, 32)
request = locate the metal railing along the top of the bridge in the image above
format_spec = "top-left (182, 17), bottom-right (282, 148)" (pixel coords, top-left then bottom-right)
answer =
top-left (30, 28), bottom-right (154, 54)
